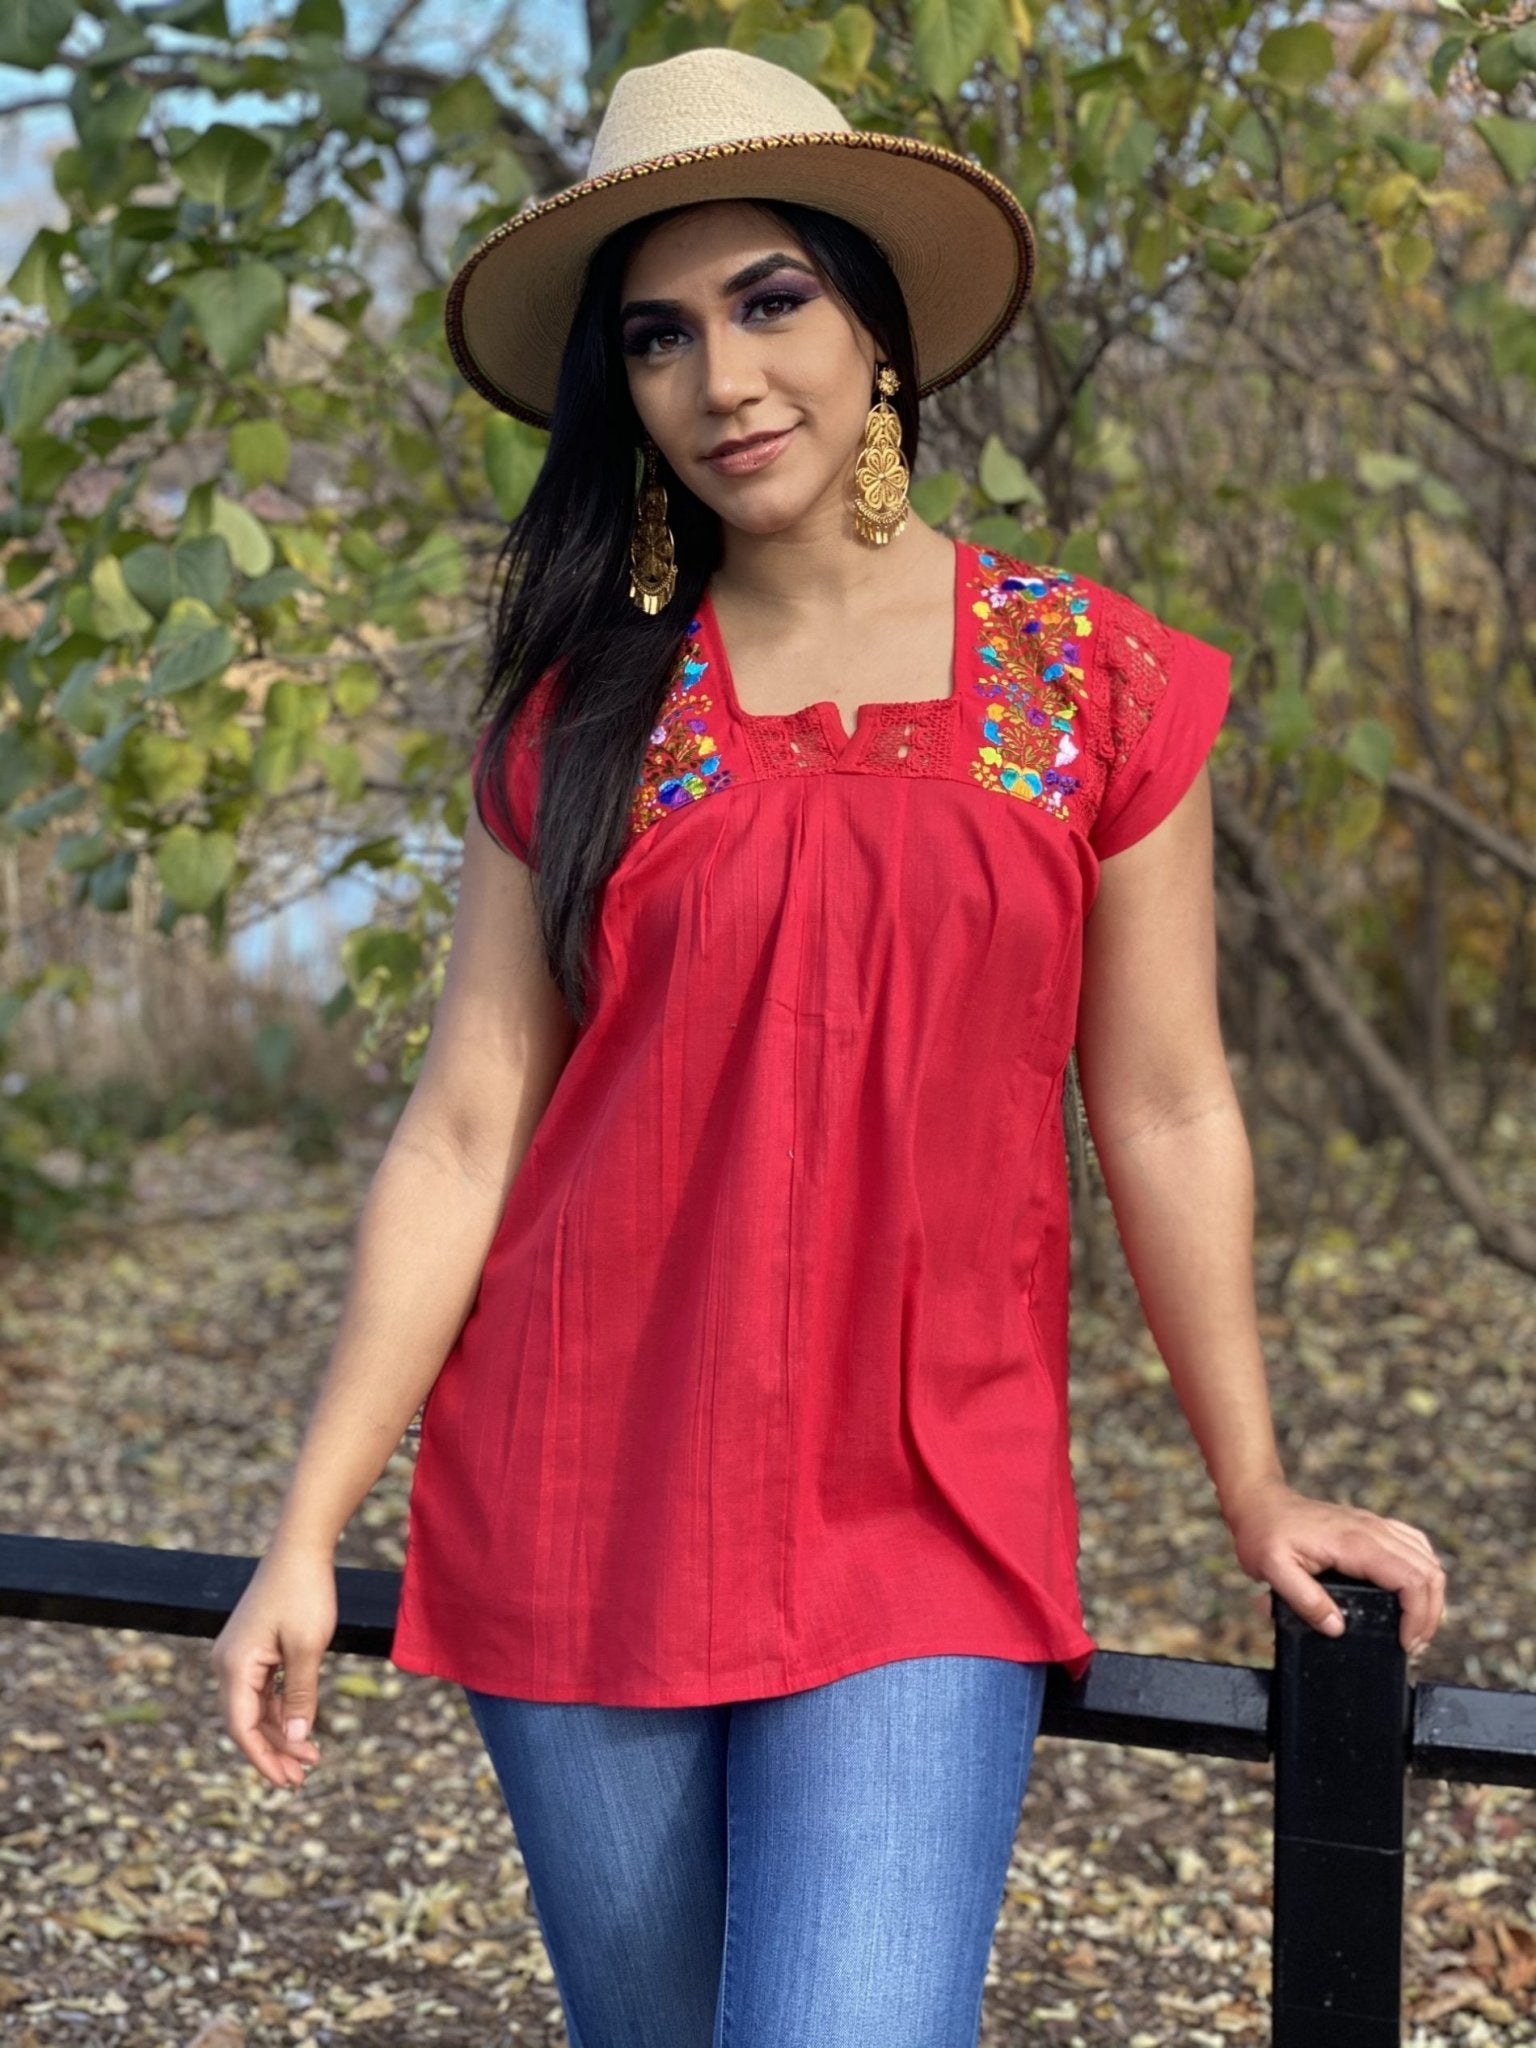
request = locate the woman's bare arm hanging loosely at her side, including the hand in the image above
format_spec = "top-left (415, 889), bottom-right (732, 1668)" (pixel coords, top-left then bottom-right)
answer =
top-left (211, 815), bottom-right (575, 1786)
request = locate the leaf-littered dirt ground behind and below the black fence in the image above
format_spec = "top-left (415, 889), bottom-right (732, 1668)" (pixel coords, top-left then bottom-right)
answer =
top-left (0, 1116), bottom-right (1536, 2048)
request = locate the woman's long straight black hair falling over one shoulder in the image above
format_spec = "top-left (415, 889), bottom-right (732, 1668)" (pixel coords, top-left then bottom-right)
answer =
top-left (475, 199), bottom-right (918, 1024)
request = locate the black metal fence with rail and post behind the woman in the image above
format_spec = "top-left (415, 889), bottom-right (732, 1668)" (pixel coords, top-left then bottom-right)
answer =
top-left (0, 1532), bottom-right (1536, 2048)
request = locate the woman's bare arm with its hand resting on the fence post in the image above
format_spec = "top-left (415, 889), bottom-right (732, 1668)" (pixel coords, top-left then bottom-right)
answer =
top-left (1077, 772), bottom-right (1444, 1647)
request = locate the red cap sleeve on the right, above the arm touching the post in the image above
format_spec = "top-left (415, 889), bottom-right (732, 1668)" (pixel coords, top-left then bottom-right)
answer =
top-left (1087, 592), bottom-right (1233, 860)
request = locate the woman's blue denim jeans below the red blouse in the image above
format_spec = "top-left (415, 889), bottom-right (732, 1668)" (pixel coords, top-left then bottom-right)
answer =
top-left (463, 1657), bottom-right (1049, 2048)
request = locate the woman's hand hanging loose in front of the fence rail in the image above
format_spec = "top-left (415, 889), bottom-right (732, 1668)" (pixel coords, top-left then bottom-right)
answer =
top-left (209, 1544), bottom-right (336, 1786)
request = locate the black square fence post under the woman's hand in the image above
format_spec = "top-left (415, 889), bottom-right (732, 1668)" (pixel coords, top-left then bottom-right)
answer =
top-left (1270, 1571), bottom-right (1411, 2048)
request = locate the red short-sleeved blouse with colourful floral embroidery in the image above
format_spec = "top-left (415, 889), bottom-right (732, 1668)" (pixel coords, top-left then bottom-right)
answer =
top-left (391, 543), bottom-right (1231, 1706)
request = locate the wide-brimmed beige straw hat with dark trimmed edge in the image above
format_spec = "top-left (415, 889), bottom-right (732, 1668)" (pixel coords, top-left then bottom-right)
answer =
top-left (444, 49), bottom-right (1034, 426)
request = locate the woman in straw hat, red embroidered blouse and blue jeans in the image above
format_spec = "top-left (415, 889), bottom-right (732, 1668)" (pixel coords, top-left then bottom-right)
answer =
top-left (215, 51), bottom-right (1444, 2048)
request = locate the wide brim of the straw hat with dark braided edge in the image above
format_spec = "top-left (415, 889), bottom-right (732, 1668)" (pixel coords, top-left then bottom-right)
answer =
top-left (444, 129), bottom-right (1034, 426)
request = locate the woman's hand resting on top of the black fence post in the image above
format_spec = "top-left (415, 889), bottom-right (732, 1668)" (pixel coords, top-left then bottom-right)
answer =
top-left (1227, 1481), bottom-right (1446, 1657)
